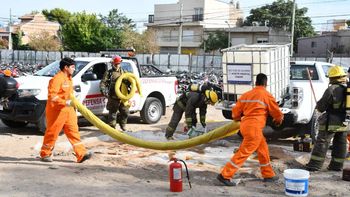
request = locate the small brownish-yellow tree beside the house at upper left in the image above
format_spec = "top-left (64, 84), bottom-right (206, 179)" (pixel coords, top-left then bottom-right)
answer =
top-left (28, 31), bottom-right (61, 51)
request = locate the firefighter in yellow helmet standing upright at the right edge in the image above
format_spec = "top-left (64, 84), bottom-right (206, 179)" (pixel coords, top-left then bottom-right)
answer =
top-left (306, 66), bottom-right (347, 171)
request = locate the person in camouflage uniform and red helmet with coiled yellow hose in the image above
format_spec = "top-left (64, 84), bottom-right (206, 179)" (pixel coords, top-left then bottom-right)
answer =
top-left (100, 56), bottom-right (129, 131)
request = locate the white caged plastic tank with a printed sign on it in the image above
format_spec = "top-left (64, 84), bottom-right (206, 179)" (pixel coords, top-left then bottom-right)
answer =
top-left (222, 44), bottom-right (290, 101)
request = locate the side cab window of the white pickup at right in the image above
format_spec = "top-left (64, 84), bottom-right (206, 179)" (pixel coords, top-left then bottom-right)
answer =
top-left (290, 64), bottom-right (318, 80)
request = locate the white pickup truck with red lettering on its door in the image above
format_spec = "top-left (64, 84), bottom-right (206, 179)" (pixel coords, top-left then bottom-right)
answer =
top-left (0, 57), bottom-right (178, 132)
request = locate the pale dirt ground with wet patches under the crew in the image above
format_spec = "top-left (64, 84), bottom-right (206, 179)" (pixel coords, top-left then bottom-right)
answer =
top-left (0, 107), bottom-right (350, 197)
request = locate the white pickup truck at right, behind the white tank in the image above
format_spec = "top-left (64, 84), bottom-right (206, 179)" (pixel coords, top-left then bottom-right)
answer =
top-left (280, 61), bottom-right (334, 138)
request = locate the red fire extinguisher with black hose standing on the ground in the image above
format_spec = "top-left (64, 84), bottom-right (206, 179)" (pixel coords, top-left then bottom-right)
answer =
top-left (169, 158), bottom-right (192, 192)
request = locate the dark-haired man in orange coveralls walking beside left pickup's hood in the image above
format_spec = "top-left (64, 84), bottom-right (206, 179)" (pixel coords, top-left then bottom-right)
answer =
top-left (40, 58), bottom-right (92, 163)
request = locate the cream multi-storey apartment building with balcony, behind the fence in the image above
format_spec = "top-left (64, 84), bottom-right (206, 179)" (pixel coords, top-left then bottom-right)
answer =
top-left (145, 0), bottom-right (243, 54)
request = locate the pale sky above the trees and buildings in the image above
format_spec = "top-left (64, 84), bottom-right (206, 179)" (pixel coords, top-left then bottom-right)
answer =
top-left (0, 0), bottom-right (350, 30)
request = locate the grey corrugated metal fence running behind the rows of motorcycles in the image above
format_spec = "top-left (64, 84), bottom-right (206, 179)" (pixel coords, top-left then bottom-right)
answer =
top-left (0, 50), bottom-right (350, 72)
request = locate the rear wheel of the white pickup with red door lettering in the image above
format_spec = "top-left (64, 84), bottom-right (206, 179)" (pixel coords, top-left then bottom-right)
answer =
top-left (140, 97), bottom-right (163, 124)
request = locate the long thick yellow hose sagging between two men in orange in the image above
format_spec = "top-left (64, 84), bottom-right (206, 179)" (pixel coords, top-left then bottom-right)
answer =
top-left (71, 95), bottom-right (239, 150)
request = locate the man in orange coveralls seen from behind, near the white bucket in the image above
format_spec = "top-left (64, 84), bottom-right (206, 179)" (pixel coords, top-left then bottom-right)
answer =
top-left (217, 73), bottom-right (283, 186)
